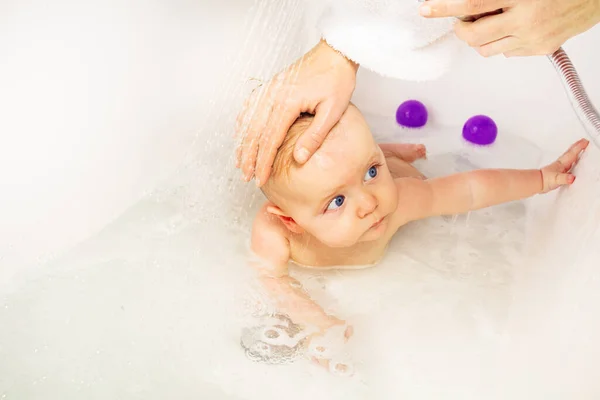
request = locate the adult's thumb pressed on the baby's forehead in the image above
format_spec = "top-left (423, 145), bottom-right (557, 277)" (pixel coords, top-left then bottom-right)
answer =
top-left (294, 99), bottom-right (348, 164)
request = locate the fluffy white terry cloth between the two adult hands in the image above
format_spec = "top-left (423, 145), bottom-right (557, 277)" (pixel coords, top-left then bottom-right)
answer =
top-left (317, 0), bottom-right (460, 81)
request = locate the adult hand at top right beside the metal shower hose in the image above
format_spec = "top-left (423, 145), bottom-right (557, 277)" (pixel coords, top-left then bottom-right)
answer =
top-left (420, 0), bottom-right (600, 57)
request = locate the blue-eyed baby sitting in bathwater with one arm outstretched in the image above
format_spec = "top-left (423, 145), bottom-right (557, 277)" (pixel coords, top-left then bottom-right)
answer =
top-left (251, 104), bottom-right (588, 368)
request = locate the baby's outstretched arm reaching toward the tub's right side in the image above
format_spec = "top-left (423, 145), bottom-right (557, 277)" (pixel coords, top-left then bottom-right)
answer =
top-left (396, 139), bottom-right (589, 224)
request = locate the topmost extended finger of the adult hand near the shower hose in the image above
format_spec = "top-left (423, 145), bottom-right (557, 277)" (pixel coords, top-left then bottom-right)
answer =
top-left (419, 0), bottom-right (514, 18)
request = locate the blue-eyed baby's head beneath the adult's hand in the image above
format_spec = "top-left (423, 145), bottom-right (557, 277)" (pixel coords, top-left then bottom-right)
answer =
top-left (263, 104), bottom-right (398, 247)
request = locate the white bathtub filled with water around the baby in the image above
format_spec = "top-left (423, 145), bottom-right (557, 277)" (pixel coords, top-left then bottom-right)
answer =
top-left (0, 0), bottom-right (600, 400)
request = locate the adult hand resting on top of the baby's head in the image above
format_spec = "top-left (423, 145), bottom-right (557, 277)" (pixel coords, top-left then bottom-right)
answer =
top-left (236, 40), bottom-right (358, 186)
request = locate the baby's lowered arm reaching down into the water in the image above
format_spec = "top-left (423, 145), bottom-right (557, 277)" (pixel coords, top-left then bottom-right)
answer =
top-left (251, 207), bottom-right (344, 332)
